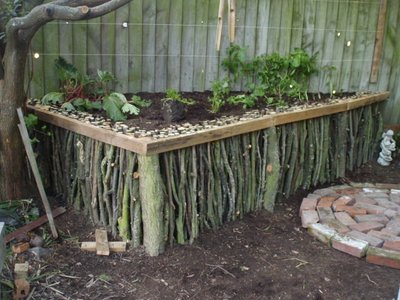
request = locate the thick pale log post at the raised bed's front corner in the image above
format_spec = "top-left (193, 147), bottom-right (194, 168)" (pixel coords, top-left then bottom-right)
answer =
top-left (138, 155), bottom-right (165, 256)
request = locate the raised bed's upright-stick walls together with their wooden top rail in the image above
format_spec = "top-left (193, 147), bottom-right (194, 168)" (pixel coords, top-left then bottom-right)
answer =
top-left (30, 93), bottom-right (389, 255)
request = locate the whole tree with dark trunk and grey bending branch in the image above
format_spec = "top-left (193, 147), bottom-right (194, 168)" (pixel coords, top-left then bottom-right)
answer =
top-left (0, 0), bottom-right (131, 201)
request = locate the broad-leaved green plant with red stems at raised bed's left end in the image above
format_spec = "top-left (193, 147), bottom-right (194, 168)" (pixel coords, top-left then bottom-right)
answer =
top-left (41, 57), bottom-right (140, 121)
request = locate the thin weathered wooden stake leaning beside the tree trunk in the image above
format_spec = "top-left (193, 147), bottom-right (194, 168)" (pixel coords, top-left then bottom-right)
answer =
top-left (17, 108), bottom-right (58, 239)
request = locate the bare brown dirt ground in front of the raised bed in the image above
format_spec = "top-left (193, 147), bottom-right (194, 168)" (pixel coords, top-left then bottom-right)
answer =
top-left (3, 154), bottom-right (400, 300)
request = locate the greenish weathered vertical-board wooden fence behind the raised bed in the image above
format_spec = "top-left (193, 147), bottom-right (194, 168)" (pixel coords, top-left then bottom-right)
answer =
top-left (30, 0), bottom-right (400, 123)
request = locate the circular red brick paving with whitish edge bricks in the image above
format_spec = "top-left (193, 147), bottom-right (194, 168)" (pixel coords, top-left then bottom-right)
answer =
top-left (300, 185), bottom-right (400, 269)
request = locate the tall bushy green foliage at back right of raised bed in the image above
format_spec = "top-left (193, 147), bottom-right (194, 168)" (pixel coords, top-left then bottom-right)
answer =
top-left (220, 44), bottom-right (318, 107)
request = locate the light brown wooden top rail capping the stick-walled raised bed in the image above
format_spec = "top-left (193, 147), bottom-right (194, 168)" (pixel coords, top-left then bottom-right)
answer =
top-left (28, 92), bottom-right (389, 155)
